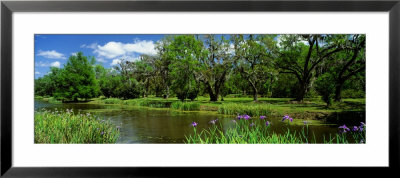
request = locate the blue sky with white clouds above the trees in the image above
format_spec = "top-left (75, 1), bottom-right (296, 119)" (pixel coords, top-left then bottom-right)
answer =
top-left (35, 34), bottom-right (164, 78)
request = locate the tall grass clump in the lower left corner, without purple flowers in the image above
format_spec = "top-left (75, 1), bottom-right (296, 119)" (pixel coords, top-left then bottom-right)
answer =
top-left (34, 110), bottom-right (120, 143)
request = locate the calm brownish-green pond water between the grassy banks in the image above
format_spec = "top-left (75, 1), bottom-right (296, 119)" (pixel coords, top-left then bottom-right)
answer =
top-left (35, 100), bottom-right (365, 143)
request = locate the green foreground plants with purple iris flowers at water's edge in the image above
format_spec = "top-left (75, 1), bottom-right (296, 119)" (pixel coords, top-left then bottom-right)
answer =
top-left (185, 114), bottom-right (365, 144)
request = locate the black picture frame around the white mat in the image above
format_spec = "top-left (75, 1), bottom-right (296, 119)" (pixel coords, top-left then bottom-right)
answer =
top-left (0, 0), bottom-right (400, 177)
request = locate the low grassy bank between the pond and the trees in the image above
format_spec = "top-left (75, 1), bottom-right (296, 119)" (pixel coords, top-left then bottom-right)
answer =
top-left (37, 95), bottom-right (365, 119)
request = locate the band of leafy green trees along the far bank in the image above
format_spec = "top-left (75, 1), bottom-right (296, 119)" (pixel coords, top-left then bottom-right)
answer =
top-left (35, 34), bottom-right (366, 105)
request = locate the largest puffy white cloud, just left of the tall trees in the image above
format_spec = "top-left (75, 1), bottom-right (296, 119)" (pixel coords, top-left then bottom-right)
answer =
top-left (93, 40), bottom-right (157, 59)
